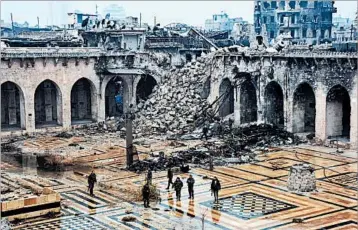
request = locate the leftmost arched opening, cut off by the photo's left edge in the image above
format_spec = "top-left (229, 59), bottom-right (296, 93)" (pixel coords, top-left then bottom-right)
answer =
top-left (1, 81), bottom-right (26, 131)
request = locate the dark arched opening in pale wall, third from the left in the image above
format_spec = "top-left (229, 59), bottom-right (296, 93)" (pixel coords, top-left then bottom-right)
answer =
top-left (71, 78), bottom-right (96, 124)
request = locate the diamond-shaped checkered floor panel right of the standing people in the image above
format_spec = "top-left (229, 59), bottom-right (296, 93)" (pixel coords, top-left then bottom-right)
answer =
top-left (201, 192), bottom-right (296, 220)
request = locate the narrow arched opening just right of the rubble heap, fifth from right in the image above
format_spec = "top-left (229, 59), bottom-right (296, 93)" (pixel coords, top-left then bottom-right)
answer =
top-left (219, 78), bottom-right (234, 117)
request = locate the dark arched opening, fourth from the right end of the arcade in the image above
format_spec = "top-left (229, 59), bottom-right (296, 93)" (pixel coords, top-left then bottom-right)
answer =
top-left (240, 80), bottom-right (257, 124)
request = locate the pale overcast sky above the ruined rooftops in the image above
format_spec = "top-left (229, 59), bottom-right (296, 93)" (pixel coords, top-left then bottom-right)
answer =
top-left (1, 0), bottom-right (357, 26)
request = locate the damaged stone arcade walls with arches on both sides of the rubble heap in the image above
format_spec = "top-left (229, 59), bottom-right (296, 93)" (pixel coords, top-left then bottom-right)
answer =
top-left (0, 48), bottom-right (358, 147)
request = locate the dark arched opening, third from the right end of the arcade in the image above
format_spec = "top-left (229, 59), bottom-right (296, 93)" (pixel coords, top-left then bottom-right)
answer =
top-left (265, 81), bottom-right (284, 128)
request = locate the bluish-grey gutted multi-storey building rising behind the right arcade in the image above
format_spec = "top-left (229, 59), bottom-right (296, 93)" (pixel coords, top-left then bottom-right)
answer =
top-left (254, 0), bottom-right (337, 44)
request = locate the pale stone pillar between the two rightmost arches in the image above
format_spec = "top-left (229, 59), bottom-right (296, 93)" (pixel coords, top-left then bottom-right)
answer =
top-left (316, 83), bottom-right (327, 141)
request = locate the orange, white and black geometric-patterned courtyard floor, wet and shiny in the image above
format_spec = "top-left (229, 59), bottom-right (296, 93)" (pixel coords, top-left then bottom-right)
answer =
top-left (5, 148), bottom-right (358, 230)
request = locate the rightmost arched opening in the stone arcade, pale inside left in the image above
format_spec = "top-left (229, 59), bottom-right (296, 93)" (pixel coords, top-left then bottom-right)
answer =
top-left (326, 85), bottom-right (351, 138)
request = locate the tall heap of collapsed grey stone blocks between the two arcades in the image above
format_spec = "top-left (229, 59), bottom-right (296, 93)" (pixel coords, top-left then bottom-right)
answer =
top-left (133, 54), bottom-right (213, 136)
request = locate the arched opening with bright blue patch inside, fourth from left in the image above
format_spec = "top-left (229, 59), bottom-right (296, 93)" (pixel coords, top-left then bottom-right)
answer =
top-left (105, 76), bottom-right (129, 117)
